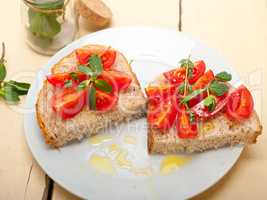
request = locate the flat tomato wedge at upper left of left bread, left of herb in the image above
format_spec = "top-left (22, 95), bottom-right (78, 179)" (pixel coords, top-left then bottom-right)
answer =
top-left (47, 72), bottom-right (88, 88)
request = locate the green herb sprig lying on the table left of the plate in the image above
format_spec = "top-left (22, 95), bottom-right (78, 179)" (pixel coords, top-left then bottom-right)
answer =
top-left (0, 43), bottom-right (30, 103)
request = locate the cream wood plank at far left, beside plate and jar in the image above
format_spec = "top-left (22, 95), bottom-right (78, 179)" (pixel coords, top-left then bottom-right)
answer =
top-left (0, 1), bottom-right (48, 200)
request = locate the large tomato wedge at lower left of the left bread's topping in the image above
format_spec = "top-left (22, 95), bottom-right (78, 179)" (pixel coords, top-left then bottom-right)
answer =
top-left (51, 88), bottom-right (87, 119)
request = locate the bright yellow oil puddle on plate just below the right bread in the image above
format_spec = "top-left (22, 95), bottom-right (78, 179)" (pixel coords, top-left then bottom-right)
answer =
top-left (160, 155), bottom-right (191, 175)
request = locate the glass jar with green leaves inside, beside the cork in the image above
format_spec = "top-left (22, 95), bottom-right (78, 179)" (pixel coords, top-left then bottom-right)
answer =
top-left (21, 0), bottom-right (78, 55)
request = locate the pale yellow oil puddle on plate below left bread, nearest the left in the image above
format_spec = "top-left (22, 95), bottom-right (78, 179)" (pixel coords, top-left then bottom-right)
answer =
top-left (89, 154), bottom-right (116, 175)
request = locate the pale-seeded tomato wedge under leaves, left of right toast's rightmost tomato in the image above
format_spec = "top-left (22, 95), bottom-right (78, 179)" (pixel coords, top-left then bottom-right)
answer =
top-left (192, 95), bottom-right (229, 119)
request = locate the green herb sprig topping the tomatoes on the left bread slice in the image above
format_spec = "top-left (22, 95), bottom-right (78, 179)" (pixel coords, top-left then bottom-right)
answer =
top-left (70, 55), bottom-right (112, 110)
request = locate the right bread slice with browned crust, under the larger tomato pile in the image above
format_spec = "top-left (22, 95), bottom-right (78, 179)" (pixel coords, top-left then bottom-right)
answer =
top-left (148, 77), bottom-right (262, 154)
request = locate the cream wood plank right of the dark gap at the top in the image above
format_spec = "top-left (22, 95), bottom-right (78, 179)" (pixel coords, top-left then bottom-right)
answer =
top-left (182, 0), bottom-right (267, 200)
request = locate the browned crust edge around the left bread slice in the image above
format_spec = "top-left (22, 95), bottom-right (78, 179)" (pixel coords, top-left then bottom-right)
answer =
top-left (35, 45), bottom-right (145, 148)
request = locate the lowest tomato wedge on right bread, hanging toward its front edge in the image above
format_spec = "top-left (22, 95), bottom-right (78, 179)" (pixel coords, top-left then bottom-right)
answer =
top-left (176, 106), bottom-right (198, 139)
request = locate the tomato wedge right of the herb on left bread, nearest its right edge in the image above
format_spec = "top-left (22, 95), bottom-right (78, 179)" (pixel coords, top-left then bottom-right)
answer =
top-left (98, 70), bottom-right (132, 92)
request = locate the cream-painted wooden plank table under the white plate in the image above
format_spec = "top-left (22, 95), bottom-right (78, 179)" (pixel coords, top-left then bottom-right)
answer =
top-left (0, 0), bottom-right (267, 200)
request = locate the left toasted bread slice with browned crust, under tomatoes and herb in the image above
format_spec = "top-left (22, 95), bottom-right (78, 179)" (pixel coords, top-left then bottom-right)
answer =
top-left (36, 45), bottom-right (146, 148)
